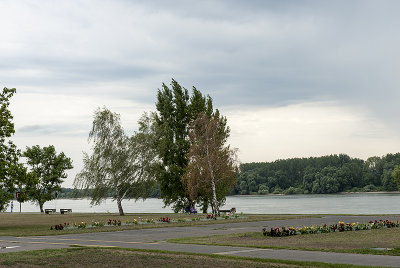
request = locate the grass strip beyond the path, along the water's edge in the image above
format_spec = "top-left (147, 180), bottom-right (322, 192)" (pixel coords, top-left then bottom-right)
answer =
top-left (0, 213), bottom-right (311, 236)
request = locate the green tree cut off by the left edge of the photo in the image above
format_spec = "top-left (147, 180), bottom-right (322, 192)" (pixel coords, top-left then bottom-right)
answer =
top-left (0, 88), bottom-right (20, 211)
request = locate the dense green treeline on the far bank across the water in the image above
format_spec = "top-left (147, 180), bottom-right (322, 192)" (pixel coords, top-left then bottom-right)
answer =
top-left (233, 153), bottom-right (400, 195)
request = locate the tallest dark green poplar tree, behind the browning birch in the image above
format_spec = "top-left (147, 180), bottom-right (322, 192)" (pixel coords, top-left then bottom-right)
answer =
top-left (154, 80), bottom-right (213, 212)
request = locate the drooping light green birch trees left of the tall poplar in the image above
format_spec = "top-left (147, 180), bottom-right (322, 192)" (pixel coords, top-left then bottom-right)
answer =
top-left (74, 108), bottom-right (157, 215)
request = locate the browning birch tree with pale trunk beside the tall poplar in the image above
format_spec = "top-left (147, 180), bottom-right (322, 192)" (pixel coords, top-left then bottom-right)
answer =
top-left (183, 113), bottom-right (238, 214)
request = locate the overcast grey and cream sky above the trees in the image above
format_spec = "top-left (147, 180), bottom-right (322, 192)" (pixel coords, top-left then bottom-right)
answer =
top-left (0, 0), bottom-right (400, 187)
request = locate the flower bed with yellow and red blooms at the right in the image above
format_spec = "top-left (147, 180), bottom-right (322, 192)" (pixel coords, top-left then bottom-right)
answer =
top-left (262, 220), bottom-right (400, 237)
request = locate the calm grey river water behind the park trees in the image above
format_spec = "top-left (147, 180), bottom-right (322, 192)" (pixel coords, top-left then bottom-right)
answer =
top-left (14, 193), bottom-right (400, 214)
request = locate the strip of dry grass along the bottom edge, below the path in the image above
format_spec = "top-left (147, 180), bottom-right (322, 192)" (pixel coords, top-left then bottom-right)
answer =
top-left (0, 247), bottom-right (370, 268)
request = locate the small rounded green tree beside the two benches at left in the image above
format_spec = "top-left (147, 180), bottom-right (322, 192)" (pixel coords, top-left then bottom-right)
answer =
top-left (23, 145), bottom-right (73, 213)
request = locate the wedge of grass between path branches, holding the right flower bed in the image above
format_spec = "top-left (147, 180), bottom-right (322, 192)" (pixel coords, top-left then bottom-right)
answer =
top-left (169, 228), bottom-right (400, 256)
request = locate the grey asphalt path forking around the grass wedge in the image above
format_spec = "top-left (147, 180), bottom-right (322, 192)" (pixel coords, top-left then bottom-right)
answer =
top-left (0, 216), bottom-right (400, 267)
